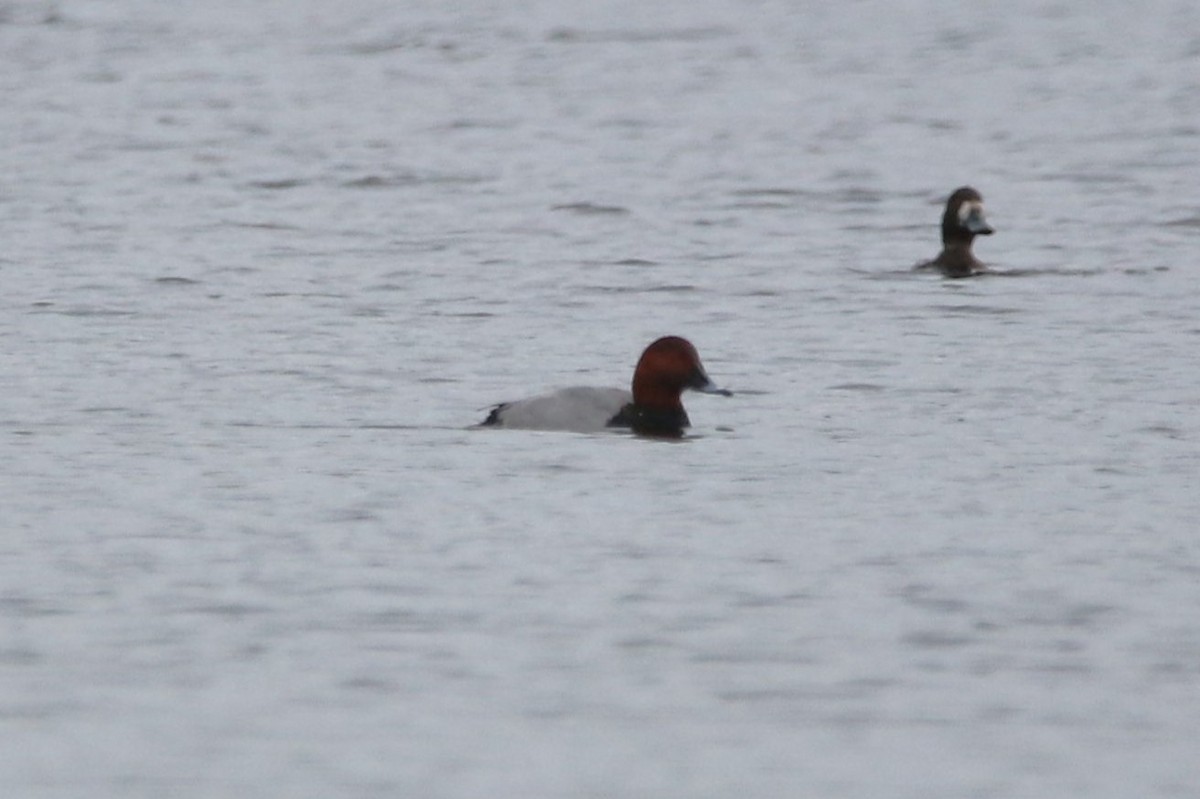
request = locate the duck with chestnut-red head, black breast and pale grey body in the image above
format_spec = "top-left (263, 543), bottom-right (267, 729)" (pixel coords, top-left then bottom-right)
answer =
top-left (480, 336), bottom-right (732, 438)
